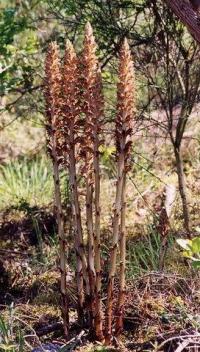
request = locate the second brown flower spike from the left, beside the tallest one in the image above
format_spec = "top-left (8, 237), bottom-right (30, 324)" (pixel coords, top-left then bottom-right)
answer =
top-left (63, 41), bottom-right (89, 323)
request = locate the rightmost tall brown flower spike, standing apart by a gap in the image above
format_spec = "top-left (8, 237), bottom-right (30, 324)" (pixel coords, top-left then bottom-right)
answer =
top-left (106, 39), bottom-right (135, 343)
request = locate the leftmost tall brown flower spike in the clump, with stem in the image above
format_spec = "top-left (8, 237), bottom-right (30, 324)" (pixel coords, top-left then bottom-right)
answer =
top-left (44, 43), bottom-right (69, 336)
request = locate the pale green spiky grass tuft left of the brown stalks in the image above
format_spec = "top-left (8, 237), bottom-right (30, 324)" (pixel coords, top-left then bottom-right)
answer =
top-left (0, 156), bottom-right (54, 209)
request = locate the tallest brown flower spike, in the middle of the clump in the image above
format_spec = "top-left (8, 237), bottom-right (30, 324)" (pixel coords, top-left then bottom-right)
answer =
top-left (82, 23), bottom-right (103, 340)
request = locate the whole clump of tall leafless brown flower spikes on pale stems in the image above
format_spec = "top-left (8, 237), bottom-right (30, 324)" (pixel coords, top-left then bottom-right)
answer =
top-left (42, 23), bottom-right (135, 344)
